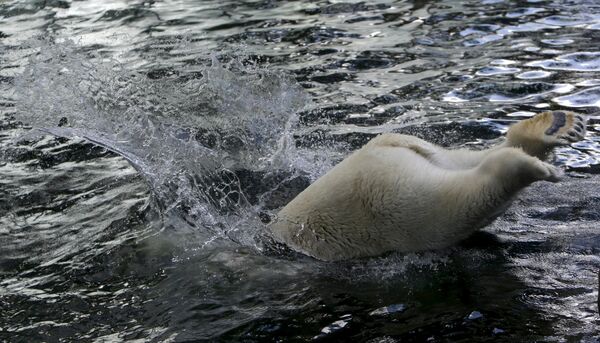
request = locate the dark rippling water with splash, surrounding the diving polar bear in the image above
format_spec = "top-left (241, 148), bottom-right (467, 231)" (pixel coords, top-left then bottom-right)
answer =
top-left (0, 0), bottom-right (600, 342)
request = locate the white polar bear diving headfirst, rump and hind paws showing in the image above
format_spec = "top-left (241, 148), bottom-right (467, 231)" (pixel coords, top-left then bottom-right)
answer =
top-left (270, 111), bottom-right (586, 261)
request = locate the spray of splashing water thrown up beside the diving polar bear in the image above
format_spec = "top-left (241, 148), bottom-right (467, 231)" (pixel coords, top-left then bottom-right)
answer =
top-left (15, 40), bottom-right (308, 244)
